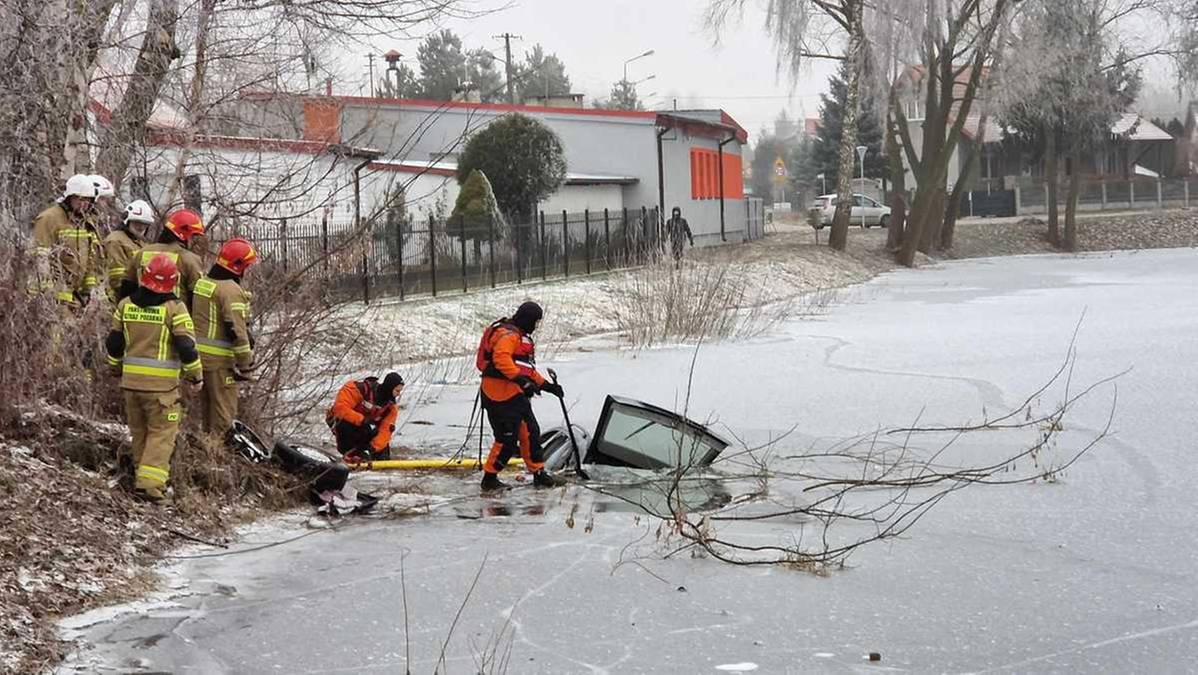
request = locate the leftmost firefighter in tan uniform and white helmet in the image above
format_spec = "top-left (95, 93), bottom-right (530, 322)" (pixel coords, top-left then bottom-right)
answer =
top-left (34, 174), bottom-right (101, 307)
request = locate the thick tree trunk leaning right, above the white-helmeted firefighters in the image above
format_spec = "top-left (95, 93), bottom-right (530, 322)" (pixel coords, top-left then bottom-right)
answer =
top-left (96, 0), bottom-right (180, 193)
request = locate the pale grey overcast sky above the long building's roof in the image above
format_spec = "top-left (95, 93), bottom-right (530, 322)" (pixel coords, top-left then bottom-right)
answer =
top-left (347, 0), bottom-right (835, 137)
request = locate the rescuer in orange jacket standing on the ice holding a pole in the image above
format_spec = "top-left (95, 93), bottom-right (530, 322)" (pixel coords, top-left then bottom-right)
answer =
top-left (478, 302), bottom-right (564, 490)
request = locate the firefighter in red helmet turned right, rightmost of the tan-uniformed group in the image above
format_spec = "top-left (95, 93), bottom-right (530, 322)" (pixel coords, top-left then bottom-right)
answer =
top-left (192, 237), bottom-right (258, 435)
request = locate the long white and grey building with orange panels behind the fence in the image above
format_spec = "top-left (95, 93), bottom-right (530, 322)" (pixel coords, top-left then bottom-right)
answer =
top-left (125, 94), bottom-right (756, 245)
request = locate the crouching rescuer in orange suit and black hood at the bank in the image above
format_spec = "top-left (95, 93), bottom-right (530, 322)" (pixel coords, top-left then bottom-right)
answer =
top-left (325, 373), bottom-right (404, 462)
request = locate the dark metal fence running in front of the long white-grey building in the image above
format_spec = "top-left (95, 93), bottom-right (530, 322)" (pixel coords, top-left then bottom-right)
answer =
top-left (254, 207), bottom-right (664, 302)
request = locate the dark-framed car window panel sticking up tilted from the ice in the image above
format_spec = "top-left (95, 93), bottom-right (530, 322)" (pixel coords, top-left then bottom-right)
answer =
top-left (587, 396), bottom-right (728, 469)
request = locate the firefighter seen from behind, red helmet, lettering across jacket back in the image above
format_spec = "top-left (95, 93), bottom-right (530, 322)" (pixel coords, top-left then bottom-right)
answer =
top-left (104, 253), bottom-right (202, 502)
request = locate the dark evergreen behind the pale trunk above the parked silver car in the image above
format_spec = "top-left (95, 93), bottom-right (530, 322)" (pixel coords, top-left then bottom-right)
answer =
top-left (812, 62), bottom-right (888, 185)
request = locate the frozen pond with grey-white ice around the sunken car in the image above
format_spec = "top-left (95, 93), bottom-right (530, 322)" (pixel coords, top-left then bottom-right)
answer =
top-left (65, 249), bottom-right (1198, 673)
